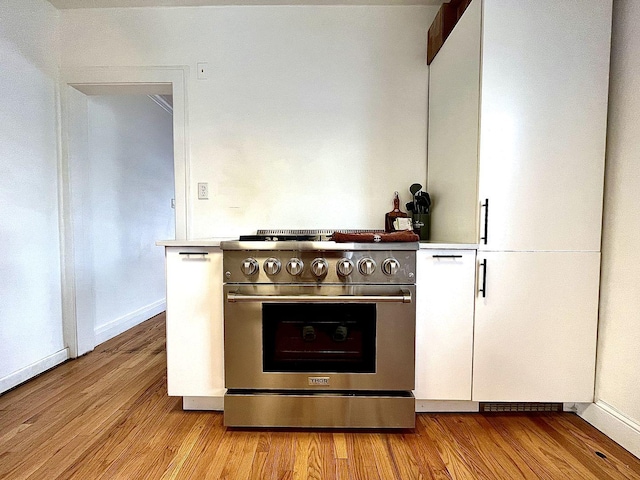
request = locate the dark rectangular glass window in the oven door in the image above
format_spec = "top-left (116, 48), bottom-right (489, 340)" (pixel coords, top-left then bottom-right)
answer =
top-left (262, 303), bottom-right (376, 373)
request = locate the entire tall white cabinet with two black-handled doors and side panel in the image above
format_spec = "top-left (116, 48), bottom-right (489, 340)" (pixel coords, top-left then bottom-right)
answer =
top-left (427, 0), bottom-right (612, 402)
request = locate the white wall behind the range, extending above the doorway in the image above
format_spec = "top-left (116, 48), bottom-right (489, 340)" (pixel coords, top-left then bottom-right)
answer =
top-left (61, 6), bottom-right (438, 238)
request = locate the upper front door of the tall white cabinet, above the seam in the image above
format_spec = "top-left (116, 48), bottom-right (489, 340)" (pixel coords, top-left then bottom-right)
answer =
top-left (478, 0), bottom-right (612, 251)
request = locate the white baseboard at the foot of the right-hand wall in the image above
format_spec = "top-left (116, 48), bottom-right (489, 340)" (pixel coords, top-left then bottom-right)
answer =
top-left (577, 400), bottom-right (640, 458)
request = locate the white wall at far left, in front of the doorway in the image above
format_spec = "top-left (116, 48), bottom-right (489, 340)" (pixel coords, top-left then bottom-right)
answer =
top-left (0, 0), bottom-right (66, 392)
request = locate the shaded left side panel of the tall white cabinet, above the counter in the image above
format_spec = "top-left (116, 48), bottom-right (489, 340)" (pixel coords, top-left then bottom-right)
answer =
top-left (427, 0), bottom-right (481, 243)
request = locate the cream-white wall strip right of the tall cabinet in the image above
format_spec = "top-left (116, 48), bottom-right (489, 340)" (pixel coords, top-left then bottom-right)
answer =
top-left (596, 0), bottom-right (640, 428)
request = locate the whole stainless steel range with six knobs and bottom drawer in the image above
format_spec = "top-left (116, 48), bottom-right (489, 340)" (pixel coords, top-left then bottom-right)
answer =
top-left (222, 231), bottom-right (417, 428)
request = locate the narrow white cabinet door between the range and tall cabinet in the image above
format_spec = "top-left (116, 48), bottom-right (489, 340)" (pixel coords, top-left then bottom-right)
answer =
top-left (414, 250), bottom-right (475, 400)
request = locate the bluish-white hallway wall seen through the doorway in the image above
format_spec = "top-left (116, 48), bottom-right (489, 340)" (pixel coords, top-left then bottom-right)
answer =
top-left (71, 95), bottom-right (175, 344)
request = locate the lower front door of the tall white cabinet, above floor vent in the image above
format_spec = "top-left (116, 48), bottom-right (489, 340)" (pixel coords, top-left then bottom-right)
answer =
top-left (472, 252), bottom-right (600, 402)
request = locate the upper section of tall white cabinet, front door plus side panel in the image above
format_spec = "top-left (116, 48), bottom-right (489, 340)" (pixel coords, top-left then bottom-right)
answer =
top-left (427, 0), bottom-right (612, 251)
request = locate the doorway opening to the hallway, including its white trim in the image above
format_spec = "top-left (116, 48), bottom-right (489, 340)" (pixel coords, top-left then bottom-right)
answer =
top-left (60, 64), bottom-right (187, 358)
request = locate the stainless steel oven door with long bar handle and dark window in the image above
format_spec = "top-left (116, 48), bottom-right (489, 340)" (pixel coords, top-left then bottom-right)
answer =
top-left (224, 285), bottom-right (415, 391)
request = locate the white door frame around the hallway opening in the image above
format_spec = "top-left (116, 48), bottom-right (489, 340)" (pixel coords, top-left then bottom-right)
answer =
top-left (58, 66), bottom-right (190, 358)
